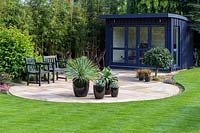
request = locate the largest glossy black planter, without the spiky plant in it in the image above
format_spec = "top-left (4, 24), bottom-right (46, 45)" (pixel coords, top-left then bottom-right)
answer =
top-left (73, 79), bottom-right (89, 97)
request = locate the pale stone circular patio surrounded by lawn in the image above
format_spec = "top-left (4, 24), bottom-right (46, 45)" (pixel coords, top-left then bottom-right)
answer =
top-left (10, 70), bottom-right (181, 103)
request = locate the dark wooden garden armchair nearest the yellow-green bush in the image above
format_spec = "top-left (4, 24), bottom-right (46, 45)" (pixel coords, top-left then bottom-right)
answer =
top-left (25, 58), bottom-right (49, 86)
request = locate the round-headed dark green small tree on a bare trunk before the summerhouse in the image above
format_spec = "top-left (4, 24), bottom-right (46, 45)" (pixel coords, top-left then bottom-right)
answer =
top-left (144, 48), bottom-right (172, 77)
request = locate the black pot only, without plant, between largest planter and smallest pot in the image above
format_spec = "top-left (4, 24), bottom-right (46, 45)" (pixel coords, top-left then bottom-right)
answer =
top-left (93, 85), bottom-right (105, 99)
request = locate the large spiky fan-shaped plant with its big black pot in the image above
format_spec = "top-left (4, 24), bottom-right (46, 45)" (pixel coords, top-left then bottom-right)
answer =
top-left (66, 56), bottom-right (99, 97)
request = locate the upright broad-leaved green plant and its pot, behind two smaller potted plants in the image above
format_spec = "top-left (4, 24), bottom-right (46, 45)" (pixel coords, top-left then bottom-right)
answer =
top-left (102, 67), bottom-right (118, 95)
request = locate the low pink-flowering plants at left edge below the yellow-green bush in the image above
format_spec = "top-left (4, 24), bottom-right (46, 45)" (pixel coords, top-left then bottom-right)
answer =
top-left (0, 72), bottom-right (12, 94)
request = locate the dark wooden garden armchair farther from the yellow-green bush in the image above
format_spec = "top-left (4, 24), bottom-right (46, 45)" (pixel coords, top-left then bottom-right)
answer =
top-left (43, 55), bottom-right (67, 83)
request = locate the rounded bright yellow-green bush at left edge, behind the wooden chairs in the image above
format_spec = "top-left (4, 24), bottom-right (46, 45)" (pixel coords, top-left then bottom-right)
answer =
top-left (0, 27), bottom-right (36, 78)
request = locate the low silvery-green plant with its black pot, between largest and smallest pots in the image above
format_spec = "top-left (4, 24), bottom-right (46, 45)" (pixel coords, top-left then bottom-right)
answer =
top-left (93, 78), bottom-right (106, 99)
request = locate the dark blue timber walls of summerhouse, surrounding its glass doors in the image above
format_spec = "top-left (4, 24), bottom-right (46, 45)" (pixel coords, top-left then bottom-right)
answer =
top-left (106, 18), bottom-right (193, 69)
